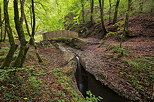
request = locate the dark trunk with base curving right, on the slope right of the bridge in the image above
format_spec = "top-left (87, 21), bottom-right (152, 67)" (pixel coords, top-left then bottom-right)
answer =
top-left (99, 0), bottom-right (107, 36)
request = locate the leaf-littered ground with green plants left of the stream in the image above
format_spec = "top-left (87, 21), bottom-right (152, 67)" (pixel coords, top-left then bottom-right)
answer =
top-left (0, 43), bottom-right (84, 102)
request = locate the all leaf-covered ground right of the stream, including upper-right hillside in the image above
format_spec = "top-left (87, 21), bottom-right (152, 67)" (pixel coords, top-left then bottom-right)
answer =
top-left (68, 13), bottom-right (154, 102)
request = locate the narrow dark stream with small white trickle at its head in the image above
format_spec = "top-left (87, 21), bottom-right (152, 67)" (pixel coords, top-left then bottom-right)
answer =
top-left (75, 56), bottom-right (131, 102)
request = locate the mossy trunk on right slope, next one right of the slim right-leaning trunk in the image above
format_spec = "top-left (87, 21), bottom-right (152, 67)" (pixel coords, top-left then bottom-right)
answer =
top-left (123, 0), bottom-right (132, 37)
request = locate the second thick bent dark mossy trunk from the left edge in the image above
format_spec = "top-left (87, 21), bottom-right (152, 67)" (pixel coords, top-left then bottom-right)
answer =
top-left (13, 0), bottom-right (27, 67)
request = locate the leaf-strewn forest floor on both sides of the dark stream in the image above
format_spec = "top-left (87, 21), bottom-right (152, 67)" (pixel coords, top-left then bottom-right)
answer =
top-left (0, 14), bottom-right (154, 102)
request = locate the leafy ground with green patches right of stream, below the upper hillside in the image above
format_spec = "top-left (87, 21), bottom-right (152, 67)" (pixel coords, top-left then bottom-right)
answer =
top-left (74, 37), bottom-right (154, 102)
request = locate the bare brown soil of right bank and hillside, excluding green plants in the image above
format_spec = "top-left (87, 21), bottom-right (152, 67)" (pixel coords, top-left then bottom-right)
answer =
top-left (66, 13), bottom-right (154, 102)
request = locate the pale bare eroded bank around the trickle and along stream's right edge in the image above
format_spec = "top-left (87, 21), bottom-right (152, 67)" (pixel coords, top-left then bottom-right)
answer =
top-left (56, 41), bottom-right (142, 102)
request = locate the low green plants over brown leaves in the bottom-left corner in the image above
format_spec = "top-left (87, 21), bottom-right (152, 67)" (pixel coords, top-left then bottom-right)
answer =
top-left (0, 67), bottom-right (42, 101)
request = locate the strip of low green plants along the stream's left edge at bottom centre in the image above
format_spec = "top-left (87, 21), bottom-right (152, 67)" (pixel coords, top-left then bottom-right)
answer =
top-left (52, 68), bottom-right (102, 102)
